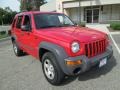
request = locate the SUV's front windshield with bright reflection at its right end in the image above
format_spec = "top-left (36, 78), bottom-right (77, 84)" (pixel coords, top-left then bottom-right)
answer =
top-left (34, 14), bottom-right (74, 29)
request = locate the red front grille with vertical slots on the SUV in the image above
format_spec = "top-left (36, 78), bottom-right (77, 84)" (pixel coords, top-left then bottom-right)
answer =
top-left (85, 40), bottom-right (106, 57)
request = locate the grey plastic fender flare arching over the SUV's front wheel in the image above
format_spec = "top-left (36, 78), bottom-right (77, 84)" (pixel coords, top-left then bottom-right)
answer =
top-left (39, 41), bottom-right (69, 73)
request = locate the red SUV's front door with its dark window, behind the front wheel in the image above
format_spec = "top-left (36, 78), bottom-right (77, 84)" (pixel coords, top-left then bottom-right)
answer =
top-left (21, 14), bottom-right (37, 57)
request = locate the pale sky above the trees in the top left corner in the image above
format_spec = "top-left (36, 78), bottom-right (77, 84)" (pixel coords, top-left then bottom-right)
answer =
top-left (0, 0), bottom-right (20, 12)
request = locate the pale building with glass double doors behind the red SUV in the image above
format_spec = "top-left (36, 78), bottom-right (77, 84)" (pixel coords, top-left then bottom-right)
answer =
top-left (41, 0), bottom-right (120, 23)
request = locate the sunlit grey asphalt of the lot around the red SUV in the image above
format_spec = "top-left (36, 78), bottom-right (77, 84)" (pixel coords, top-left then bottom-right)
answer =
top-left (0, 35), bottom-right (120, 90)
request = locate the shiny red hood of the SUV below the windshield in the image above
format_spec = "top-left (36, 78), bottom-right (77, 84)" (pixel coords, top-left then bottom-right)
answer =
top-left (37, 27), bottom-right (105, 42)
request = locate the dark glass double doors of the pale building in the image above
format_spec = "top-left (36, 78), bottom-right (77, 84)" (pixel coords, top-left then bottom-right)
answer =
top-left (86, 8), bottom-right (99, 23)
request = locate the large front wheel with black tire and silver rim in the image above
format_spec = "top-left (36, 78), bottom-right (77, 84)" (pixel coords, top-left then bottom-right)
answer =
top-left (42, 52), bottom-right (65, 85)
